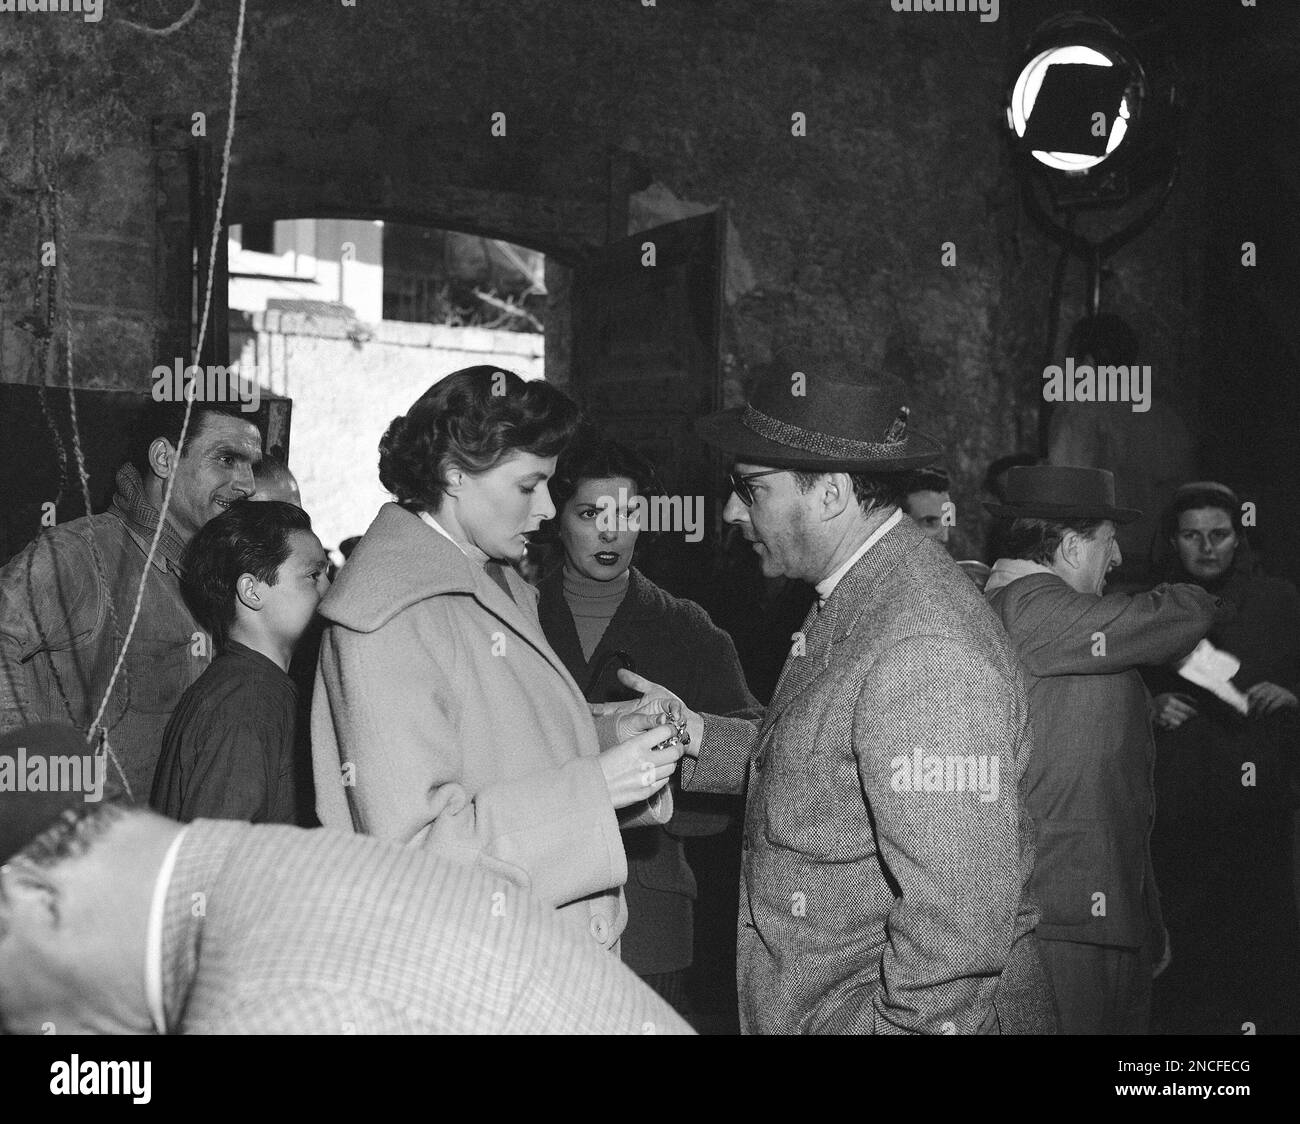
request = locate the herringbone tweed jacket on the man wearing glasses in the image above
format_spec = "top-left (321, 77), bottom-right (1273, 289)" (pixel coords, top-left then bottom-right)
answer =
top-left (683, 520), bottom-right (1056, 1033)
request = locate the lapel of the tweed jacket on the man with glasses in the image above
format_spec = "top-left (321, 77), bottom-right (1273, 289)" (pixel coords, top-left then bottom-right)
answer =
top-left (763, 518), bottom-right (926, 729)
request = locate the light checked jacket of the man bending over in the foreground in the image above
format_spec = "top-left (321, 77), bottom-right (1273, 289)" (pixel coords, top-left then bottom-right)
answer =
top-left (163, 820), bottom-right (690, 1034)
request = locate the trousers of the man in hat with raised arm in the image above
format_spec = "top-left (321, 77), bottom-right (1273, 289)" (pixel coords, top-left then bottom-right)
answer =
top-left (1039, 941), bottom-right (1152, 1034)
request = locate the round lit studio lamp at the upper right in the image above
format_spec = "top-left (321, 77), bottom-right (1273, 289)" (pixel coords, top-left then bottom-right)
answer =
top-left (1004, 3), bottom-right (1179, 205)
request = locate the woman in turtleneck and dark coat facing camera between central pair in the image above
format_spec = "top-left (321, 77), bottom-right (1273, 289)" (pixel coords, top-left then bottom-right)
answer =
top-left (538, 438), bottom-right (757, 1019)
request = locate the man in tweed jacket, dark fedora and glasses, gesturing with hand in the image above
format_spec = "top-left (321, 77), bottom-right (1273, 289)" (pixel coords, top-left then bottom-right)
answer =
top-left (598, 373), bottom-right (1054, 1034)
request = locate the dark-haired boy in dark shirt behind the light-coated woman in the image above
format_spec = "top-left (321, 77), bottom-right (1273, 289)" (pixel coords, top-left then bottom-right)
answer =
top-left (150, 500), bottom-right (329, 824)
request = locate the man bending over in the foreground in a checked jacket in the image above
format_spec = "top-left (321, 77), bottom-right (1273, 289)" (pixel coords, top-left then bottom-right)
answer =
top-left (0, 724), bottom-right (690, 1034)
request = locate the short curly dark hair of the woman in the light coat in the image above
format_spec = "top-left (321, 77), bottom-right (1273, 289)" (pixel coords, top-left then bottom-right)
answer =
top-left (380, 366), bottom-right (579, 511)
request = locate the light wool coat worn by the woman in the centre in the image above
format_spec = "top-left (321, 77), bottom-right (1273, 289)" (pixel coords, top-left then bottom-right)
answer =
top-left (312, 503), bottom-right (671, 949)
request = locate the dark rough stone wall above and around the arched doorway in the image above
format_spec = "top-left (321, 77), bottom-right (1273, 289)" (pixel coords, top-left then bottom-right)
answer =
top-left (0, 0), bottom-right (1289, 561)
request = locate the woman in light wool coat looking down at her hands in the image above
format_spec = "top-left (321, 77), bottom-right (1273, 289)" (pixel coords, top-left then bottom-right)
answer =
top-left (312, 366), bottom-right (681, 950)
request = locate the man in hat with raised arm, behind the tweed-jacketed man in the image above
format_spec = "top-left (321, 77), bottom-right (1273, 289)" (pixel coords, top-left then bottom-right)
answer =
top-left (984, 465), bottom-right (1218, 1034)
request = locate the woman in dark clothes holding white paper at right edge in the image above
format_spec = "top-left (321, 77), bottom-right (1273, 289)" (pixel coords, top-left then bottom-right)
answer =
top-left (1144, 481), bottom-right (1300, 1034)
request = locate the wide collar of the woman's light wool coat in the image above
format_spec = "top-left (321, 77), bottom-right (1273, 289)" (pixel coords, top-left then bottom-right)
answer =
top-left (320, 503), bottom-right (564, 674)
